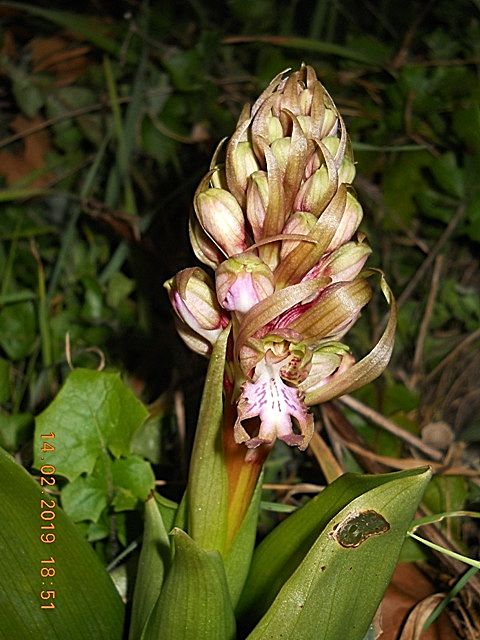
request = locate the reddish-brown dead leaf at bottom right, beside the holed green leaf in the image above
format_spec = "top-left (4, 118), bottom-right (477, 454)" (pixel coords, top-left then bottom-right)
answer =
top-left (379, 562), bottom-right (458, 640)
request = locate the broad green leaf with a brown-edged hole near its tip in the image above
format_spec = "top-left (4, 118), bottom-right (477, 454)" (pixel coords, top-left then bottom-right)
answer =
top-left (248, 469), bottom-right (430, 640)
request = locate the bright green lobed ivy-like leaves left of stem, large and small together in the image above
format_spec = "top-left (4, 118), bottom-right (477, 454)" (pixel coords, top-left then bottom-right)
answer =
top-left (34, 369), bottom-right (155, 539)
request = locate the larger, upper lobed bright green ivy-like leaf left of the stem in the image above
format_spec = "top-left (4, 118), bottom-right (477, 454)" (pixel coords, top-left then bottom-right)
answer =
top-left (34, 369), bottom-right (147, 480)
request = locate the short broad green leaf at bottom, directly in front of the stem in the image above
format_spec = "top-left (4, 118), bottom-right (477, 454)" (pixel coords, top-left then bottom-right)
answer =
top-left (144, 529), bottom-right (235, 640)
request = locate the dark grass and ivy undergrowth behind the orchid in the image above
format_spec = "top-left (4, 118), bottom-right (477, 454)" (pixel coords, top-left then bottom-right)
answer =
top-left (0, 0), bottom-right (480, 637)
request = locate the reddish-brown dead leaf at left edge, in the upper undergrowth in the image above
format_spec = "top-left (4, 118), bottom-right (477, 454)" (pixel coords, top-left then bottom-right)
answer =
top-left (0, 115), bottom-right (52, 187)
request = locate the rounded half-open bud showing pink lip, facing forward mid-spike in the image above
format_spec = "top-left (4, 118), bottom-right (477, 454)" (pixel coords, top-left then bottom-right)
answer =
top-left (215, 254), bottom-right (275, 313)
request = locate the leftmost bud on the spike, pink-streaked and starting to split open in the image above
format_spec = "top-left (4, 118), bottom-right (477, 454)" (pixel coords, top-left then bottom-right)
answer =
top-left (164, 267), bottom-right (228, 344)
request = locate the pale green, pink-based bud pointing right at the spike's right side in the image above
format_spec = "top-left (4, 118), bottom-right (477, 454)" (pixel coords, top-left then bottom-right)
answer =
top-left (314, 242), bottom-right (372, 283)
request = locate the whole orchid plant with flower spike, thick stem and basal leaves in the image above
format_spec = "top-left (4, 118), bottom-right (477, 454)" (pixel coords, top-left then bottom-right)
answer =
top-left (142, 65), bottom-right (428, 640)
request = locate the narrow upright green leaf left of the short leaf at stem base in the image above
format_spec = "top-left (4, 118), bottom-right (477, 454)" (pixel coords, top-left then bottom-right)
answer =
top-left (129, 494), bottom-right (170, 640)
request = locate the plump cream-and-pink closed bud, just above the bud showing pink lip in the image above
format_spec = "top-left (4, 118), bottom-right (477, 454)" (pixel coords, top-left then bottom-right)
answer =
top-left (194, 188), bottom-right (247, 256)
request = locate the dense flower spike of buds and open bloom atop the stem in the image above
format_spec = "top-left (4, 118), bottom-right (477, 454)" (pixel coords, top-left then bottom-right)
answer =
top-left (167, 66), bottom-right (395, 449)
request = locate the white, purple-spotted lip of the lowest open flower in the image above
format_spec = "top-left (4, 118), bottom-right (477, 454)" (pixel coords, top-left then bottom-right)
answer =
top-left (234, 350), bottom-right (313, 451)
